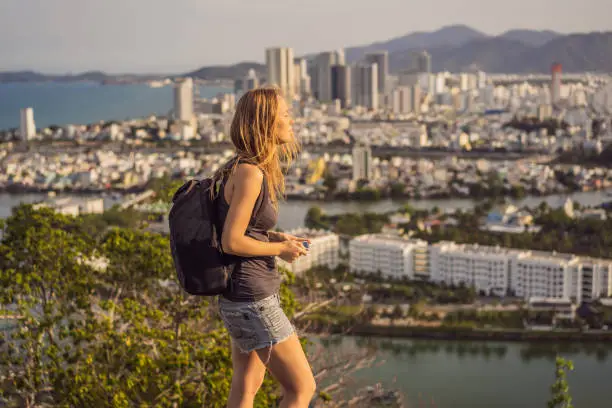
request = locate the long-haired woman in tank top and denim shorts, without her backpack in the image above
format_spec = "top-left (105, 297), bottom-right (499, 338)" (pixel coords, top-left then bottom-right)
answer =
top-left (217, 89), bottom-right (316, 408)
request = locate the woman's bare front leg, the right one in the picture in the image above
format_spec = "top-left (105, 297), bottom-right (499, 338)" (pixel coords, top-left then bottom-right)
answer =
top-left (257, 333), bottom-right (316, 408)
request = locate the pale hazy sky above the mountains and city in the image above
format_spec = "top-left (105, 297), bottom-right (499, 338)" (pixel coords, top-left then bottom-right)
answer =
top-left (0, 0), bottom-right (612, 73)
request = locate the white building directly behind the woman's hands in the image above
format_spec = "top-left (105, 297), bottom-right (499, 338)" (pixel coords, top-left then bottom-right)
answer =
top-left (278, 228), bottom-right (340, 275)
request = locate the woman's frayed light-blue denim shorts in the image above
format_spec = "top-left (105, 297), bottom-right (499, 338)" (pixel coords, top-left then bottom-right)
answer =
top-left (219, 294), bottom-right (295, 353)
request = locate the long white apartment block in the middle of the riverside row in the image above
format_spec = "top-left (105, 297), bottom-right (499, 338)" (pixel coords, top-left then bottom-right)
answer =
top-left (429, 242), bottom-right (521, 296)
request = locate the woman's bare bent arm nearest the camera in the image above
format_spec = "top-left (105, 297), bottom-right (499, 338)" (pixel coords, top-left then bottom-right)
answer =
top-left (221, 163), bottom-right (305, 257)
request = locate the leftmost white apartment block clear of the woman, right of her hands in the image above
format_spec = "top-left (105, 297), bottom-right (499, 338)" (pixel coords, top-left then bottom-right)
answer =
top-left (349, 234), bottom-right (429, 279)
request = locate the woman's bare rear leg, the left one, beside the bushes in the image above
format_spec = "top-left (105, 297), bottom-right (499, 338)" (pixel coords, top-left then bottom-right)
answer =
top-left (227, 341), bottom-right (266, 408)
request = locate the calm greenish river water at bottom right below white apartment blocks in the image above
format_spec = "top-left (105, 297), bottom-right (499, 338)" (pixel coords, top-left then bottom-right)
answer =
top-left (314, 337), bottom-right (612, 408)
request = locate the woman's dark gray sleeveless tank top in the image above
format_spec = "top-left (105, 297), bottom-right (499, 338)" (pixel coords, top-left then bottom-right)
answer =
top-left (217, 164), bottom-right (281, 302)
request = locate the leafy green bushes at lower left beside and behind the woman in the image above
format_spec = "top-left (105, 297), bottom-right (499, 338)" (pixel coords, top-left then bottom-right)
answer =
top-left (0, 206), bottom-right (299, 408)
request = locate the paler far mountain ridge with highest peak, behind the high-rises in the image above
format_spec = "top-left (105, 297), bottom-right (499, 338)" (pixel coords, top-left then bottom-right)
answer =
top-left (345, 25), bottom-right (487, 62)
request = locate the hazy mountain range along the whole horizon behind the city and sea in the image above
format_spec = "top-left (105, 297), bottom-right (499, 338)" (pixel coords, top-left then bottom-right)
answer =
top-left (0, 25), bottom-right (612, 84)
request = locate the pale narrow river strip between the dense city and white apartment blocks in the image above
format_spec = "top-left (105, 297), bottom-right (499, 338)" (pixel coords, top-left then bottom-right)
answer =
top-left (0, 191), bottom-right (612, 230)
